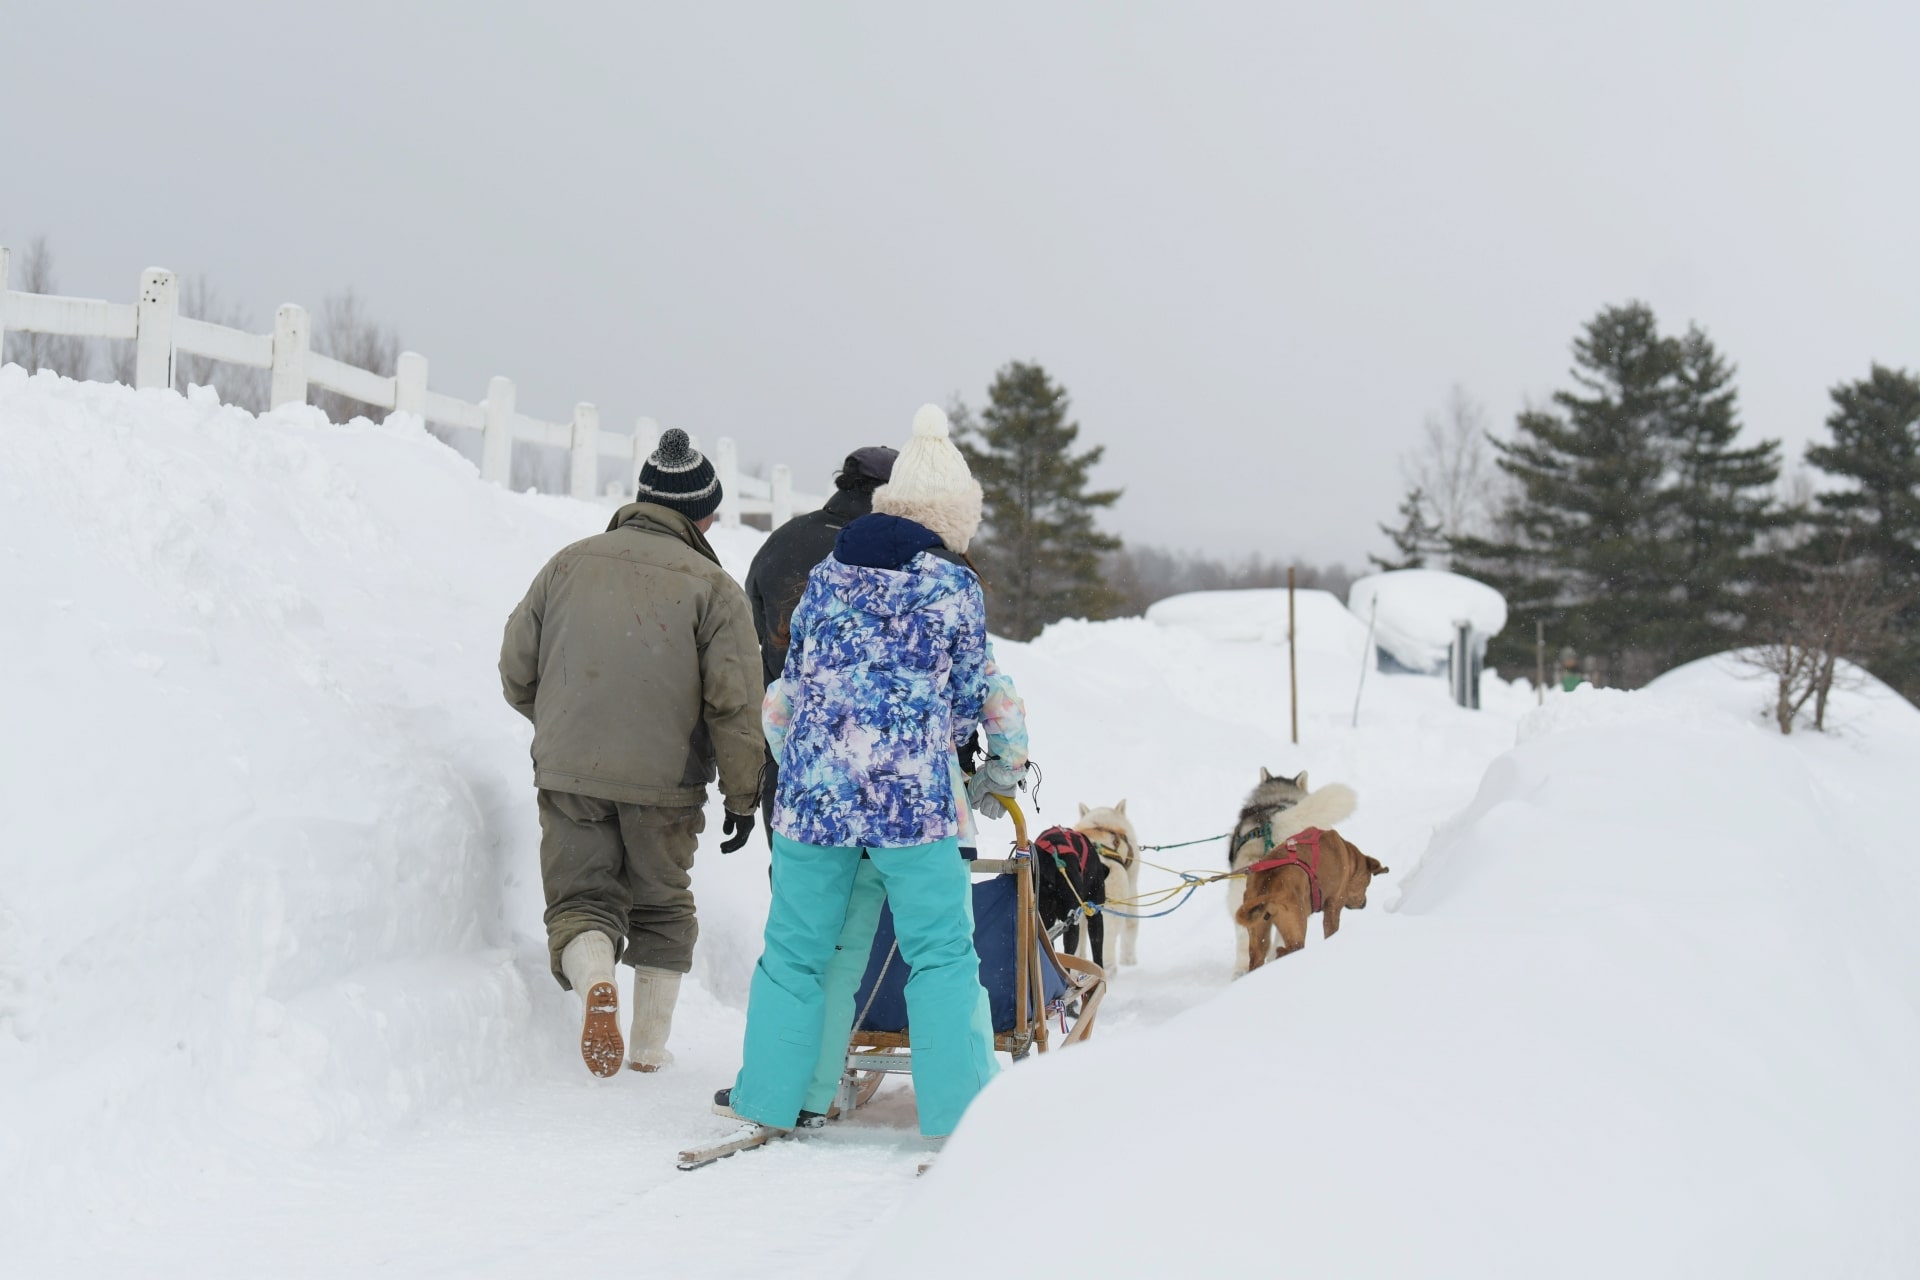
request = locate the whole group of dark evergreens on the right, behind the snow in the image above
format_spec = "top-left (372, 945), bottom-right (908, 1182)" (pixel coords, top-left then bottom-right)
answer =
top-left (1436, 301), bottom-right (1920, 697)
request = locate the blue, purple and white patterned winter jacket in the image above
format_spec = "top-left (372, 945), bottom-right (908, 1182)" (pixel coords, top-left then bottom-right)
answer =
top-left (764, 516), bottom-right (987, 848)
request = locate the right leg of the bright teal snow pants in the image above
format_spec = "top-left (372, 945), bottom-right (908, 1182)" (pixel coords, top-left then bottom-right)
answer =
top-left (868, 839), bottom-right (1000, 1138)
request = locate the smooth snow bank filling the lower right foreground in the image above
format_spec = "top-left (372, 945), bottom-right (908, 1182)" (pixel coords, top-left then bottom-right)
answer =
top-left (870, 668), bottom-right (1920, 1276)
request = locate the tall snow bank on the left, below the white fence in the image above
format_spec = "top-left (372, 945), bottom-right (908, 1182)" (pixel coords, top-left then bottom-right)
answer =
top-left (0, 367), bottom-right (766, 1238)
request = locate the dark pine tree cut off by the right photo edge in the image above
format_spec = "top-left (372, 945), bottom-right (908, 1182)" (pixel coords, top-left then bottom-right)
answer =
top-left (1807, 365), bottom-right (1920, 699)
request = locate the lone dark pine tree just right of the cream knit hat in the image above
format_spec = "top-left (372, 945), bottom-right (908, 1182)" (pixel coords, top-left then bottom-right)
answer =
top-left (952, 361), bottom-right (1121, 639)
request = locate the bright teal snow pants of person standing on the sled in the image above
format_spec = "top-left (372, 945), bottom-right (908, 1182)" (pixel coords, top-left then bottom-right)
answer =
top-left (730, 833), bottom-right (998, 1136)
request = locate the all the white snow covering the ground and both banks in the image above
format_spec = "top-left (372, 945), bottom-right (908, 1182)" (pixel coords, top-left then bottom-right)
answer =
top-left (0, 367), bottom-right (1920, 1278)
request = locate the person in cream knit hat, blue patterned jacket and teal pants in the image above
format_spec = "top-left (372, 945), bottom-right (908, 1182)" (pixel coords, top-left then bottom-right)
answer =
top-left (728, 405), bottom-right (998, 1136)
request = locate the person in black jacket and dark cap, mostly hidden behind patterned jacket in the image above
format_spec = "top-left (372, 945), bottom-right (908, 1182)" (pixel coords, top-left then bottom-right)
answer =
top-left (745, 445), bottom-right (899, 842)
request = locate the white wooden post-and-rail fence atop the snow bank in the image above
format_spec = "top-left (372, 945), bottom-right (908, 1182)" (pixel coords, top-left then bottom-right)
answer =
top-left (0, 246), bottom-right (824, 528)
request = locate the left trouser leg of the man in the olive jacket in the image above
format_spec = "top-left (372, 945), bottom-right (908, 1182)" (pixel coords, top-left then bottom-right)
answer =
top-left (540, 791), bottom-right (632, 990)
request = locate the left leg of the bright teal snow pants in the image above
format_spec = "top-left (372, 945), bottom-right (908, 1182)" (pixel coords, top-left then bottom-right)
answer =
top-left (728, 833), bottom-right (860, 1128)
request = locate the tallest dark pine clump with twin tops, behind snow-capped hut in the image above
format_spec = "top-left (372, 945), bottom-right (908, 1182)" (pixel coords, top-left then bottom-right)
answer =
top-left (1455, 303), bottom-right (1780, 685)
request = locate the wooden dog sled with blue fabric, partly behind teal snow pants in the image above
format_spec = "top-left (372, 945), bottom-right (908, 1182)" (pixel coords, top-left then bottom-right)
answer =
top-left (835, 798), bottom-right (1106, 1117)
